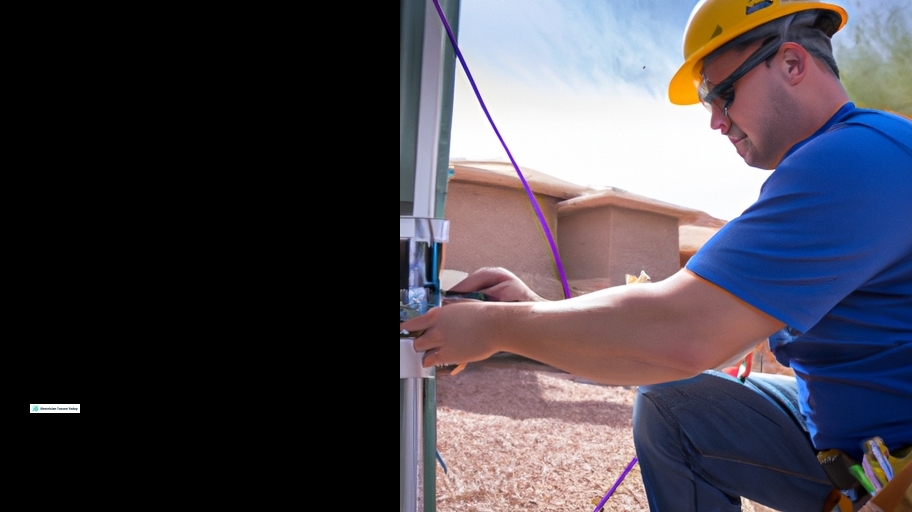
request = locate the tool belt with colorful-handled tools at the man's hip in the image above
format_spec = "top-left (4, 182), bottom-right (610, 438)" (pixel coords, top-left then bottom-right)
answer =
top-left (817, 437), bottom-right (912, 512)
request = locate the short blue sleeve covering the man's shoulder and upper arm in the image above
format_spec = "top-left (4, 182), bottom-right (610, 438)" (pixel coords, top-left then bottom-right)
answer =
top-left (687, 122), bottom-right (912, 332)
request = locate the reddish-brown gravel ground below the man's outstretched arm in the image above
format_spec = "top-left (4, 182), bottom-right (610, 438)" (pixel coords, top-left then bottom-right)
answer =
top-left (437, 354), bottom-right (771, 512)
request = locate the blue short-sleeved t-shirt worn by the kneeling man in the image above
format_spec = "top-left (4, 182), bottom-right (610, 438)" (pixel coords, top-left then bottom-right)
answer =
top-left (687, 103), bottom-right (912, 460)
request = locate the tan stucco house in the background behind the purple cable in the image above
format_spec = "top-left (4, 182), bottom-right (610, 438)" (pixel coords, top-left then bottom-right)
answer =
top-left (442, 161), bottom-right (718, 299)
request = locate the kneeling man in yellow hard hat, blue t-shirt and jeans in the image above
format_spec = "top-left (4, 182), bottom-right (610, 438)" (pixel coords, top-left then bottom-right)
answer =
top-left (402, 0), bottom-right (912, 511)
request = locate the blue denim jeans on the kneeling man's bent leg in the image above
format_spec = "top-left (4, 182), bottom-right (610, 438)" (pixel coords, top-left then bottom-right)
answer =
top-left (633, 371), bottom-right (833, 512)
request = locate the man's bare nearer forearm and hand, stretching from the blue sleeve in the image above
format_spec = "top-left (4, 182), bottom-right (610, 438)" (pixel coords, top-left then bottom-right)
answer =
top-left (403, 270), bottom-right (783, 384)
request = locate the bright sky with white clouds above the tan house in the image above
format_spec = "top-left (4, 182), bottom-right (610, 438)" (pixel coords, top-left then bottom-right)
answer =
top-left (450, 0), bottom-right (876, 219)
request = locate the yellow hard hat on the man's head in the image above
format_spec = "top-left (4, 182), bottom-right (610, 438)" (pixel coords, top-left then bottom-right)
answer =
top-left (668, 0), bottom-right (848, 105)
